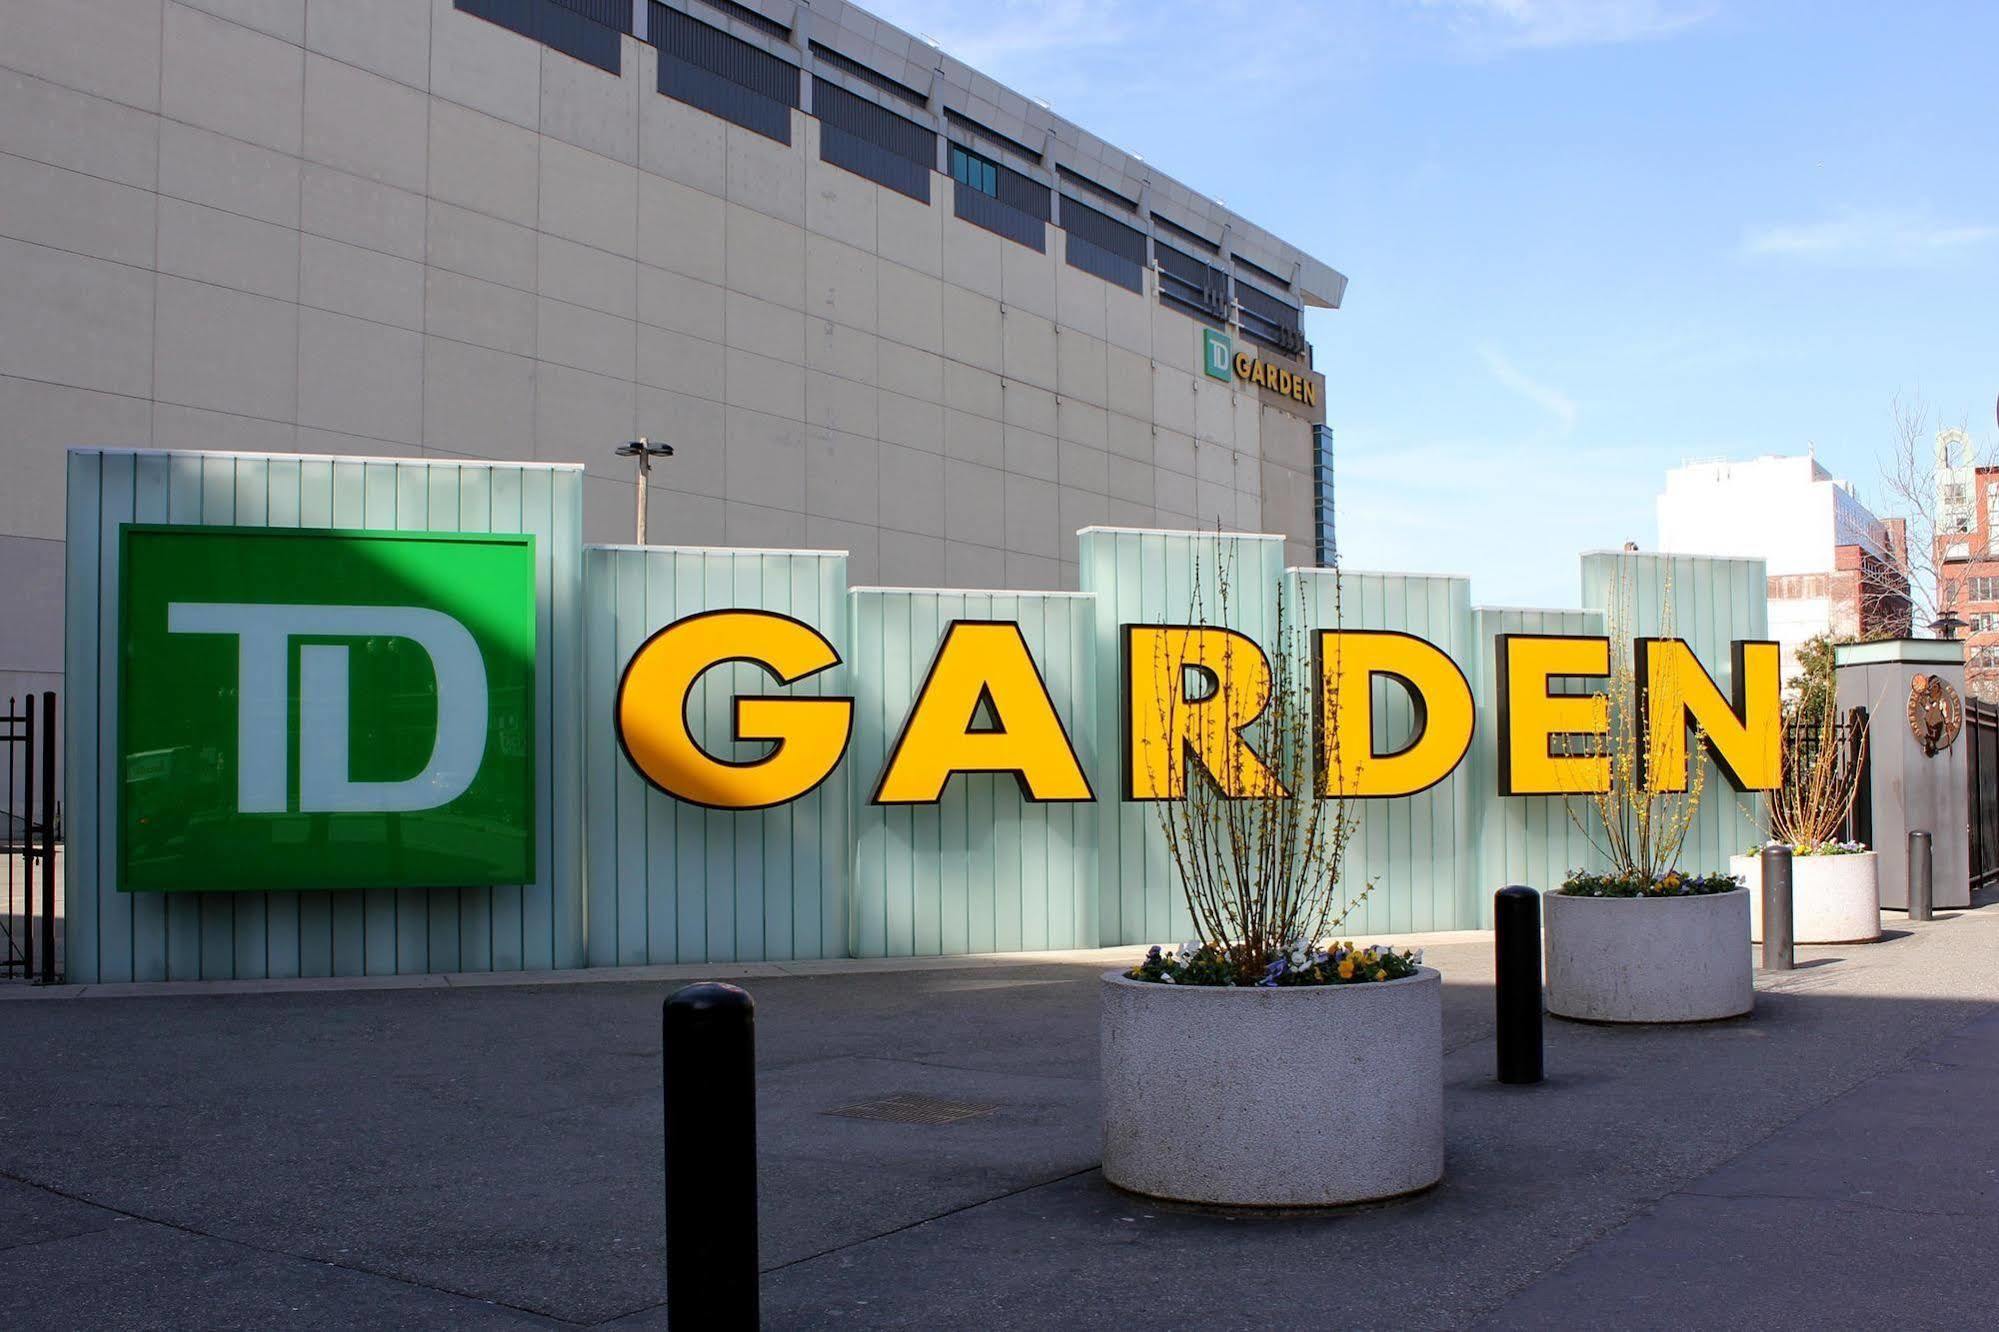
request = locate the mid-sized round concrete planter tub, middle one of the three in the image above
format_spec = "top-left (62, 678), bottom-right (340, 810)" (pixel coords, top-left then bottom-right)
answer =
top-left (1541, 888), bottom-right (1755, 1022)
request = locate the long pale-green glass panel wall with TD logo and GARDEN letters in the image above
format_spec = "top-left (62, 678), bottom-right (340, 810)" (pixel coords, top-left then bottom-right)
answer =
top-left (68, 450), bottom-right (1779, 980)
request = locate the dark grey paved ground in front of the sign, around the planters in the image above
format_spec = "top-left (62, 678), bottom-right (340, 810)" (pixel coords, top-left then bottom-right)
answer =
top-left (0, 908), bottom-right (1999, 1328)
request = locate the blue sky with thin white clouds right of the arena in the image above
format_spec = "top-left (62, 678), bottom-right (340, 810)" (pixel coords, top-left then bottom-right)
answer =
top-left (870, 0), bottom-right (1999, 606)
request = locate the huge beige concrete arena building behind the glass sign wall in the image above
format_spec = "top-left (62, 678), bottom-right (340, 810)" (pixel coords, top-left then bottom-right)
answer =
top-left (0, 0), bottom-right (1345, 694)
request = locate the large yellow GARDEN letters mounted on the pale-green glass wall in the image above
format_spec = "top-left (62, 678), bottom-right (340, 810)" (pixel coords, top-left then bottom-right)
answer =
top-left (616, 610), bottom-right (1781, 810)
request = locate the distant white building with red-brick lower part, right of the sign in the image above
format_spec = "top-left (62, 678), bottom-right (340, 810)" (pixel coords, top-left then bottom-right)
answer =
top-left (1659, 454), bottom-right (1909, 676)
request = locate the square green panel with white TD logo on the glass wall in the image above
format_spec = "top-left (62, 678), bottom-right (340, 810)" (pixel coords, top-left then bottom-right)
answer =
top-left (118, 524), bottom-right (536, 892)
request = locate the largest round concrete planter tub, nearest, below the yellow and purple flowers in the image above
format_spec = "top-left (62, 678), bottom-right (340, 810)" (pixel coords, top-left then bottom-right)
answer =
top-left (1103, 966), bottom-right (1443, 1208)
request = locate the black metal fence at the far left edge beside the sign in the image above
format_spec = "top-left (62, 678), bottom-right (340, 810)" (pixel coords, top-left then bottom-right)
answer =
top-left (0, 694), bottom-right (62, 982)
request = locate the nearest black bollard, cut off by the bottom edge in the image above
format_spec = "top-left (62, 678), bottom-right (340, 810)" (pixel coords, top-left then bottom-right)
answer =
top-left (660, 982), bottom-right (760, 1332)
